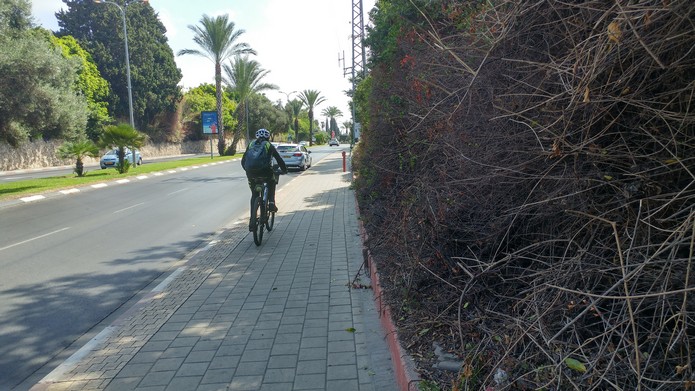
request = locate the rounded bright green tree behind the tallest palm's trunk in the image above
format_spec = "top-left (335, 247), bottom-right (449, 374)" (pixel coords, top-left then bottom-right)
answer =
top-left (181, 84), bottom-right (237, 140)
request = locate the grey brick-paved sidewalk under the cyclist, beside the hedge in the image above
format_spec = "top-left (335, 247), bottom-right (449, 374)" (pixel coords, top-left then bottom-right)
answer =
top-left (32, 153), bottom-right (397, 391)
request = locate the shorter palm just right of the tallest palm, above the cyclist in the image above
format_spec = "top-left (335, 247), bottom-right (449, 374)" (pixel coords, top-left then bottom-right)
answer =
top-left (224, 56), bottom-right (278, 155)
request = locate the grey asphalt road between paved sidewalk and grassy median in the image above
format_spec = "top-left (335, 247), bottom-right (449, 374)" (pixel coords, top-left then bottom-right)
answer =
top-left (0, 147), bottom-right (331, 390)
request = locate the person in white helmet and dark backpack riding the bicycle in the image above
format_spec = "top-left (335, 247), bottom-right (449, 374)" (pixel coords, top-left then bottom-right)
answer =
top-left (241, 129), bottom-right (287, 225)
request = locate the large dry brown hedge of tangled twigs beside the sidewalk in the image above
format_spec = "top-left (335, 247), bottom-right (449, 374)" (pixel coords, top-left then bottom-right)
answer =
top-left (355, 0), bottom-right (695, 390)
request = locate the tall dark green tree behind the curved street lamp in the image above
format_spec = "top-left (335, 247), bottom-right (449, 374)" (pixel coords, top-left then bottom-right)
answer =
top-left (56, 0), bottom-right (181, 133)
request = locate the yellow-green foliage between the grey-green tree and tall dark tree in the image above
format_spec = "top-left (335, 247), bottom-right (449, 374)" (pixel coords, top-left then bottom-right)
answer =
top-left (50, 35), bottom-right (111, 140)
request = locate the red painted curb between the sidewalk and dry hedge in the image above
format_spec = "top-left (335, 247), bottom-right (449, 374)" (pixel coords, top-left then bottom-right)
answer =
top-left (355, 199), bottom-right (420, 391)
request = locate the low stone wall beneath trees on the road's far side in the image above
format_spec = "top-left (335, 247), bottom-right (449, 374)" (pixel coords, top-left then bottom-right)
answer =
top-left (0, 140), bottom-right (223, 171)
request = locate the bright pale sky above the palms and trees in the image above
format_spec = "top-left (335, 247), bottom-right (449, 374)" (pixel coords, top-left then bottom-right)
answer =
top-left (30, 0), bottom-right (375, 123)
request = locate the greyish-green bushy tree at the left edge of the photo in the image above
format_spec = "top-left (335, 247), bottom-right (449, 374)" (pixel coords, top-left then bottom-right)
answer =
top-left (0, 0), bottom-right (87, 146)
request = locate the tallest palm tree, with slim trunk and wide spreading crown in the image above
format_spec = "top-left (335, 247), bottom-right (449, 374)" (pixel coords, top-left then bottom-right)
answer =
top-left (178, 15), bottom-right (256, 155)
